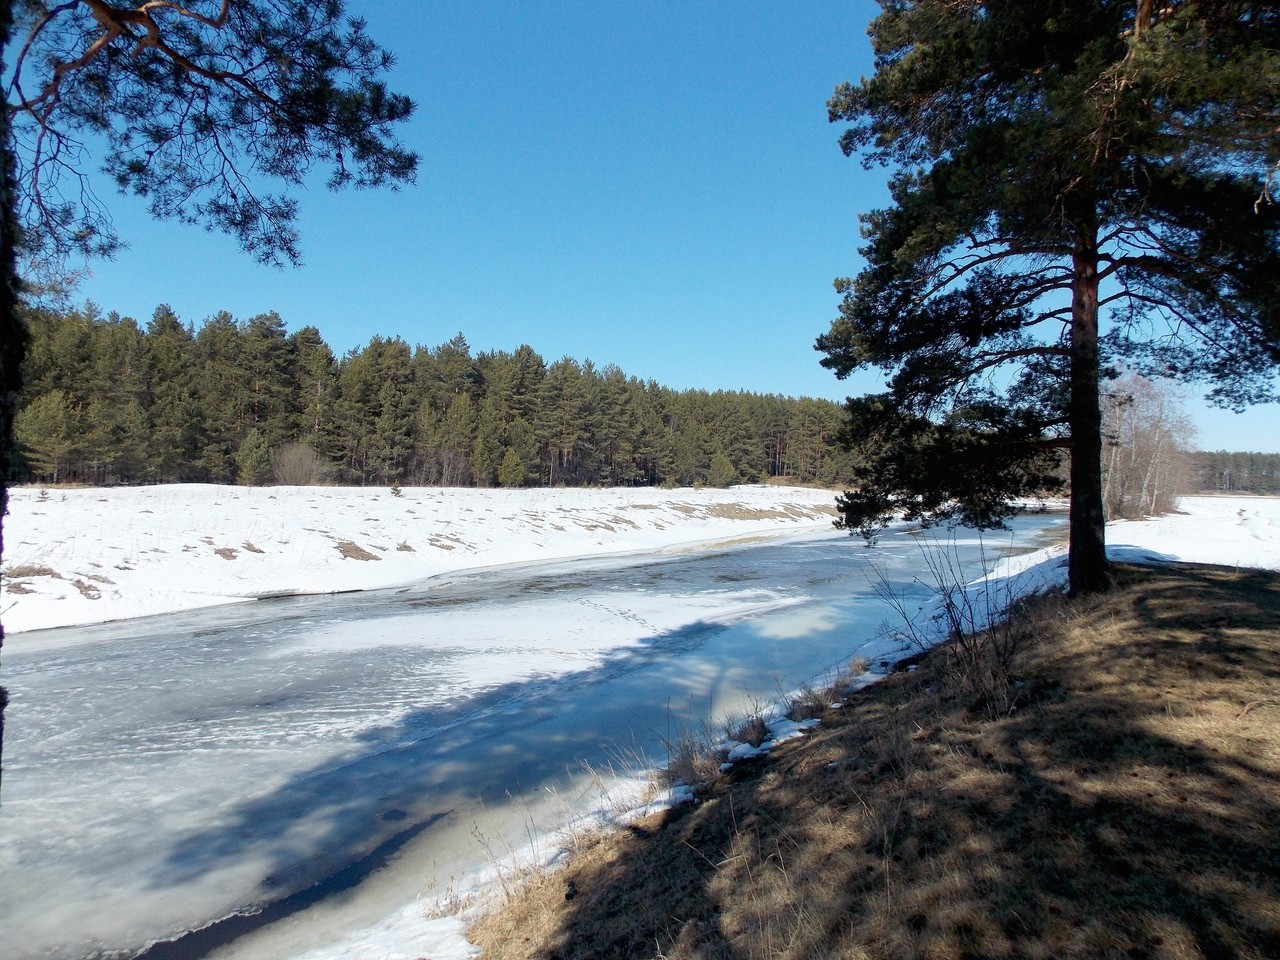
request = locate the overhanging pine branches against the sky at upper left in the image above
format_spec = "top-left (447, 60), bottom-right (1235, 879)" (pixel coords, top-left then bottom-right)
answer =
top-left (6, 0), bottom-right (417, 269)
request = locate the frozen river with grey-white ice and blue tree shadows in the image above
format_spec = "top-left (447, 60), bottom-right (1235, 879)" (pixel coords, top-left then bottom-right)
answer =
top-left (0, 517), bottom-right (1061, 960)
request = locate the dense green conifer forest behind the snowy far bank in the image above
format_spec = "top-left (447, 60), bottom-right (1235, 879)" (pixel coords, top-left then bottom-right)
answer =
top-left (12, 305), bottom-right (852, 486)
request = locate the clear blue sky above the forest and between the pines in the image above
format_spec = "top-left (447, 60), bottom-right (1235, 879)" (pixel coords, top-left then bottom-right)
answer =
top-left (78, 0), bottom-right (1280, 451)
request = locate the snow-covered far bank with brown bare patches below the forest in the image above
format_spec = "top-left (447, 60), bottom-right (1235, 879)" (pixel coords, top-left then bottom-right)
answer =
top-left (0, 484), bottom-right (835, 634)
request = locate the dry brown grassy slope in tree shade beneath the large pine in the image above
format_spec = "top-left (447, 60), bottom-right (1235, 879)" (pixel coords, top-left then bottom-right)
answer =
top-left (472, 567), bottom-right (1280, 960)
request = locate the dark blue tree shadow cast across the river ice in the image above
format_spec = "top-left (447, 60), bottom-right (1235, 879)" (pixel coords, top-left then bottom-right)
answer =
top-left (138, 611), bottom-right (747, 960)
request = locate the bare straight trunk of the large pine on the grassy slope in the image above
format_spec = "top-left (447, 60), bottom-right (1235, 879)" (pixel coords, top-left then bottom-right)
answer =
top-left (1068, 239), bottom-right (1111, 595)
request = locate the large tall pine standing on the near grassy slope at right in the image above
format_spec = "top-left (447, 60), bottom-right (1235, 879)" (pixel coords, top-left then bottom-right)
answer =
top-left (818, 0), bottom-right (1280, 593)
